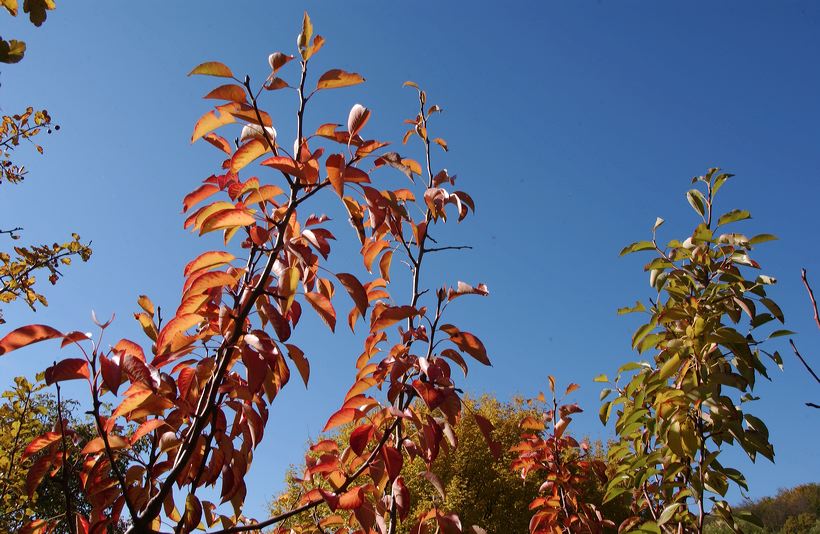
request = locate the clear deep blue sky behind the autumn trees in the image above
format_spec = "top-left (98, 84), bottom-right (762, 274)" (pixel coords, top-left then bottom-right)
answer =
top-left (0, 1), bottom-right (820, 516)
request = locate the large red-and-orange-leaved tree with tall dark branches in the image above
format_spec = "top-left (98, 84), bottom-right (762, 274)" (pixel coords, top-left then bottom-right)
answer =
top-left (0, 15), bottom-right (490, 533)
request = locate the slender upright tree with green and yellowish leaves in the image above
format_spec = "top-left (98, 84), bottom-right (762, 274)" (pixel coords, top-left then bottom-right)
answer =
top-left (597, 169), bottom-right (790, 533)
